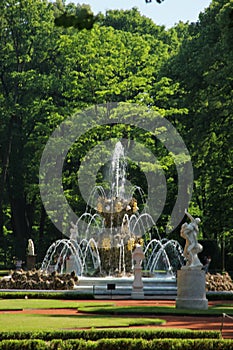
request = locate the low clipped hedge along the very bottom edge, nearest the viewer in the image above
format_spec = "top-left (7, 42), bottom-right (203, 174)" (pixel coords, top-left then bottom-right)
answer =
top-left (0, 339), bottom-right (233, 350)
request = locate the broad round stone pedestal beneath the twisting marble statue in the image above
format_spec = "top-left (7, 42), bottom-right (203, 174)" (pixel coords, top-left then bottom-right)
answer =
top-left (176, 269), bottom-right (208, 310)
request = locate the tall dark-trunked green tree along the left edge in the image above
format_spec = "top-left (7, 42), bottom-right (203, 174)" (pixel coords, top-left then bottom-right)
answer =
top-left (0, 0), bottom-right (67, 258)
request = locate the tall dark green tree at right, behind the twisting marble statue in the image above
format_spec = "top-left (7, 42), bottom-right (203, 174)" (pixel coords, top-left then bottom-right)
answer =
top-left (162, 0), bottom-right (233, 262)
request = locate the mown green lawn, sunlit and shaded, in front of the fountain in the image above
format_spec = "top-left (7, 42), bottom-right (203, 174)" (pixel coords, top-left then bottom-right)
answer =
top-left (0, 299), bottom-right (233, 331)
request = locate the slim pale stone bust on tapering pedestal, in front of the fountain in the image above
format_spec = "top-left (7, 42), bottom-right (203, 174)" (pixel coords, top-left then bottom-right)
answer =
top-left (131, 245), bottom-right (145, 299)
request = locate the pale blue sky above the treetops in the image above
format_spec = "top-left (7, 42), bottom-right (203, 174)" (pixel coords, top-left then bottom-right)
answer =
top-left (72, 0), bottom-right (211, 28)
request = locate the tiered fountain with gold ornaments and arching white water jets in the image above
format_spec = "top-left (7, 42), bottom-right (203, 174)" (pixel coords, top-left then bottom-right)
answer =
top-left (41, 142), bottom-right (184, 296)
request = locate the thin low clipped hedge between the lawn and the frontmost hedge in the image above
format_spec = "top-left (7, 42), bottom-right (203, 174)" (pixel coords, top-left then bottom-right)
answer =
top-left (0, 329), bottom-right (221, 341)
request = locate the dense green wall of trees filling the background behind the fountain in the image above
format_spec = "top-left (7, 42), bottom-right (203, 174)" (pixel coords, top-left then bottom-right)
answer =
top-left (0, 0), bottom-right (233, 268)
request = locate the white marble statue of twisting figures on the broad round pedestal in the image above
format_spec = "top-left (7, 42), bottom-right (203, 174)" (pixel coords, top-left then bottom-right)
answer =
top-left (180, 209), bottom-right (203, 269)
